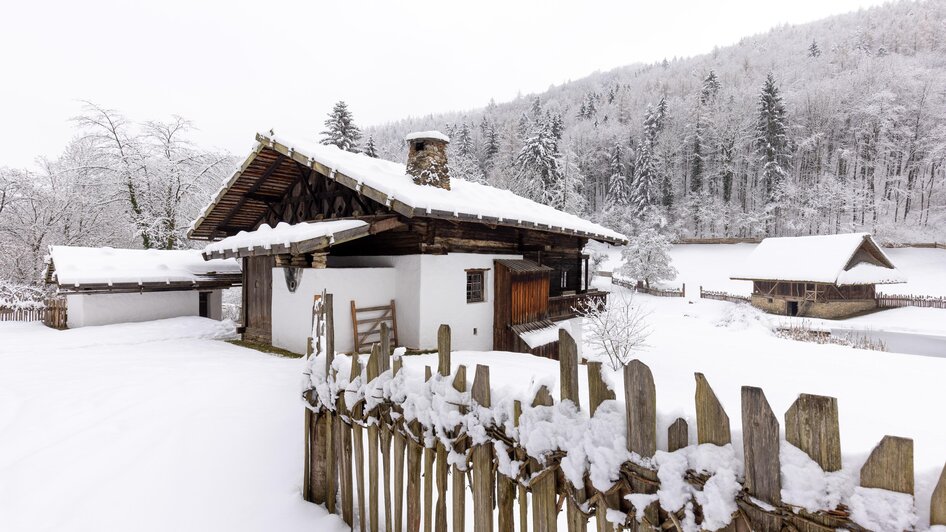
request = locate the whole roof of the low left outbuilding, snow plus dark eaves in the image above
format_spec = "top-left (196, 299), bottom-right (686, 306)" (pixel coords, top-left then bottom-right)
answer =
top-left (46, 246), bottom-right (242, 292)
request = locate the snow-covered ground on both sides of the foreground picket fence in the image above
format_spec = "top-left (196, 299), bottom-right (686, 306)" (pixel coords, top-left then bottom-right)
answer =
top-left (0, 294), bottom-right (946, 531)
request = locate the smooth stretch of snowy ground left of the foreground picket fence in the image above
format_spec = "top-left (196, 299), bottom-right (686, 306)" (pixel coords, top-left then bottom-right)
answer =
top-left (0, 318), bottom-right (345, 532)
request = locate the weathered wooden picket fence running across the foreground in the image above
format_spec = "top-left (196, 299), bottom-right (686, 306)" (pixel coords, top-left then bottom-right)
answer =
top-left (303, 299), bottom-right (946, 532)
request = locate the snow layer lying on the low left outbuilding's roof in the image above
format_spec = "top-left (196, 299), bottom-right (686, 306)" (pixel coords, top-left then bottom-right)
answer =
top-left (48, 246), bottom-right (241, 287)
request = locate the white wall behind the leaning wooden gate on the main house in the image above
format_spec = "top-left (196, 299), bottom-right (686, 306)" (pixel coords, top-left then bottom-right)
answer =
top-left (272, 268), bottom-right (401, 353)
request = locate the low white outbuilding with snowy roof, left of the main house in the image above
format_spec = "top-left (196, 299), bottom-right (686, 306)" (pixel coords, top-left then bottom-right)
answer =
top-left (45, 246), bottom-right (243, 328)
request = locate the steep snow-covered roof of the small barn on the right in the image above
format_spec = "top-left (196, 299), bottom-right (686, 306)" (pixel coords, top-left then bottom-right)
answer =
top-left (732, 233), bottom-right (906, 286)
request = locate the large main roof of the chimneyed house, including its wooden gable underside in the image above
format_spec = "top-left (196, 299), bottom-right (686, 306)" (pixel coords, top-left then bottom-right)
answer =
top-left (188, 133), bottom-right (627, 244)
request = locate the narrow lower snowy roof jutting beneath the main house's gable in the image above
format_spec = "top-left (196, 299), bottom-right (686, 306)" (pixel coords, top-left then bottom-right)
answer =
top-left (204, 220), bottom-right (371, 260)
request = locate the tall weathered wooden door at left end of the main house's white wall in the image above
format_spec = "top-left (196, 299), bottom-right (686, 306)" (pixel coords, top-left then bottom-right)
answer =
top-left (243, 257), bottom-right (274, 344)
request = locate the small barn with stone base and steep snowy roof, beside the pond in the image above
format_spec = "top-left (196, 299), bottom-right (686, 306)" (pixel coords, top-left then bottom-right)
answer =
top-left (732, 233), bottom-right (906, 318)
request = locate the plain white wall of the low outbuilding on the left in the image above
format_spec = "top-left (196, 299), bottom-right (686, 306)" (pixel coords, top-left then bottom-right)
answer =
top-left (66, 290), bottom-right (199, 329)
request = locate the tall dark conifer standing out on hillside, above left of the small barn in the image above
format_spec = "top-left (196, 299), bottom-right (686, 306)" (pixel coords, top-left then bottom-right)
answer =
top-left (756, 72), bottom-right (788, 204)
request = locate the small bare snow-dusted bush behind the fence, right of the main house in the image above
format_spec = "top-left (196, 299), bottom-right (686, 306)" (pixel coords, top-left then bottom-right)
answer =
top-left (576, 293), bottom-right (650, 371)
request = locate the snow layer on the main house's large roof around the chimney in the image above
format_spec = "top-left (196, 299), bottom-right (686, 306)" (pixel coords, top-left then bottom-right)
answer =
top-left (191, 132), bottom-right (627, 242)
